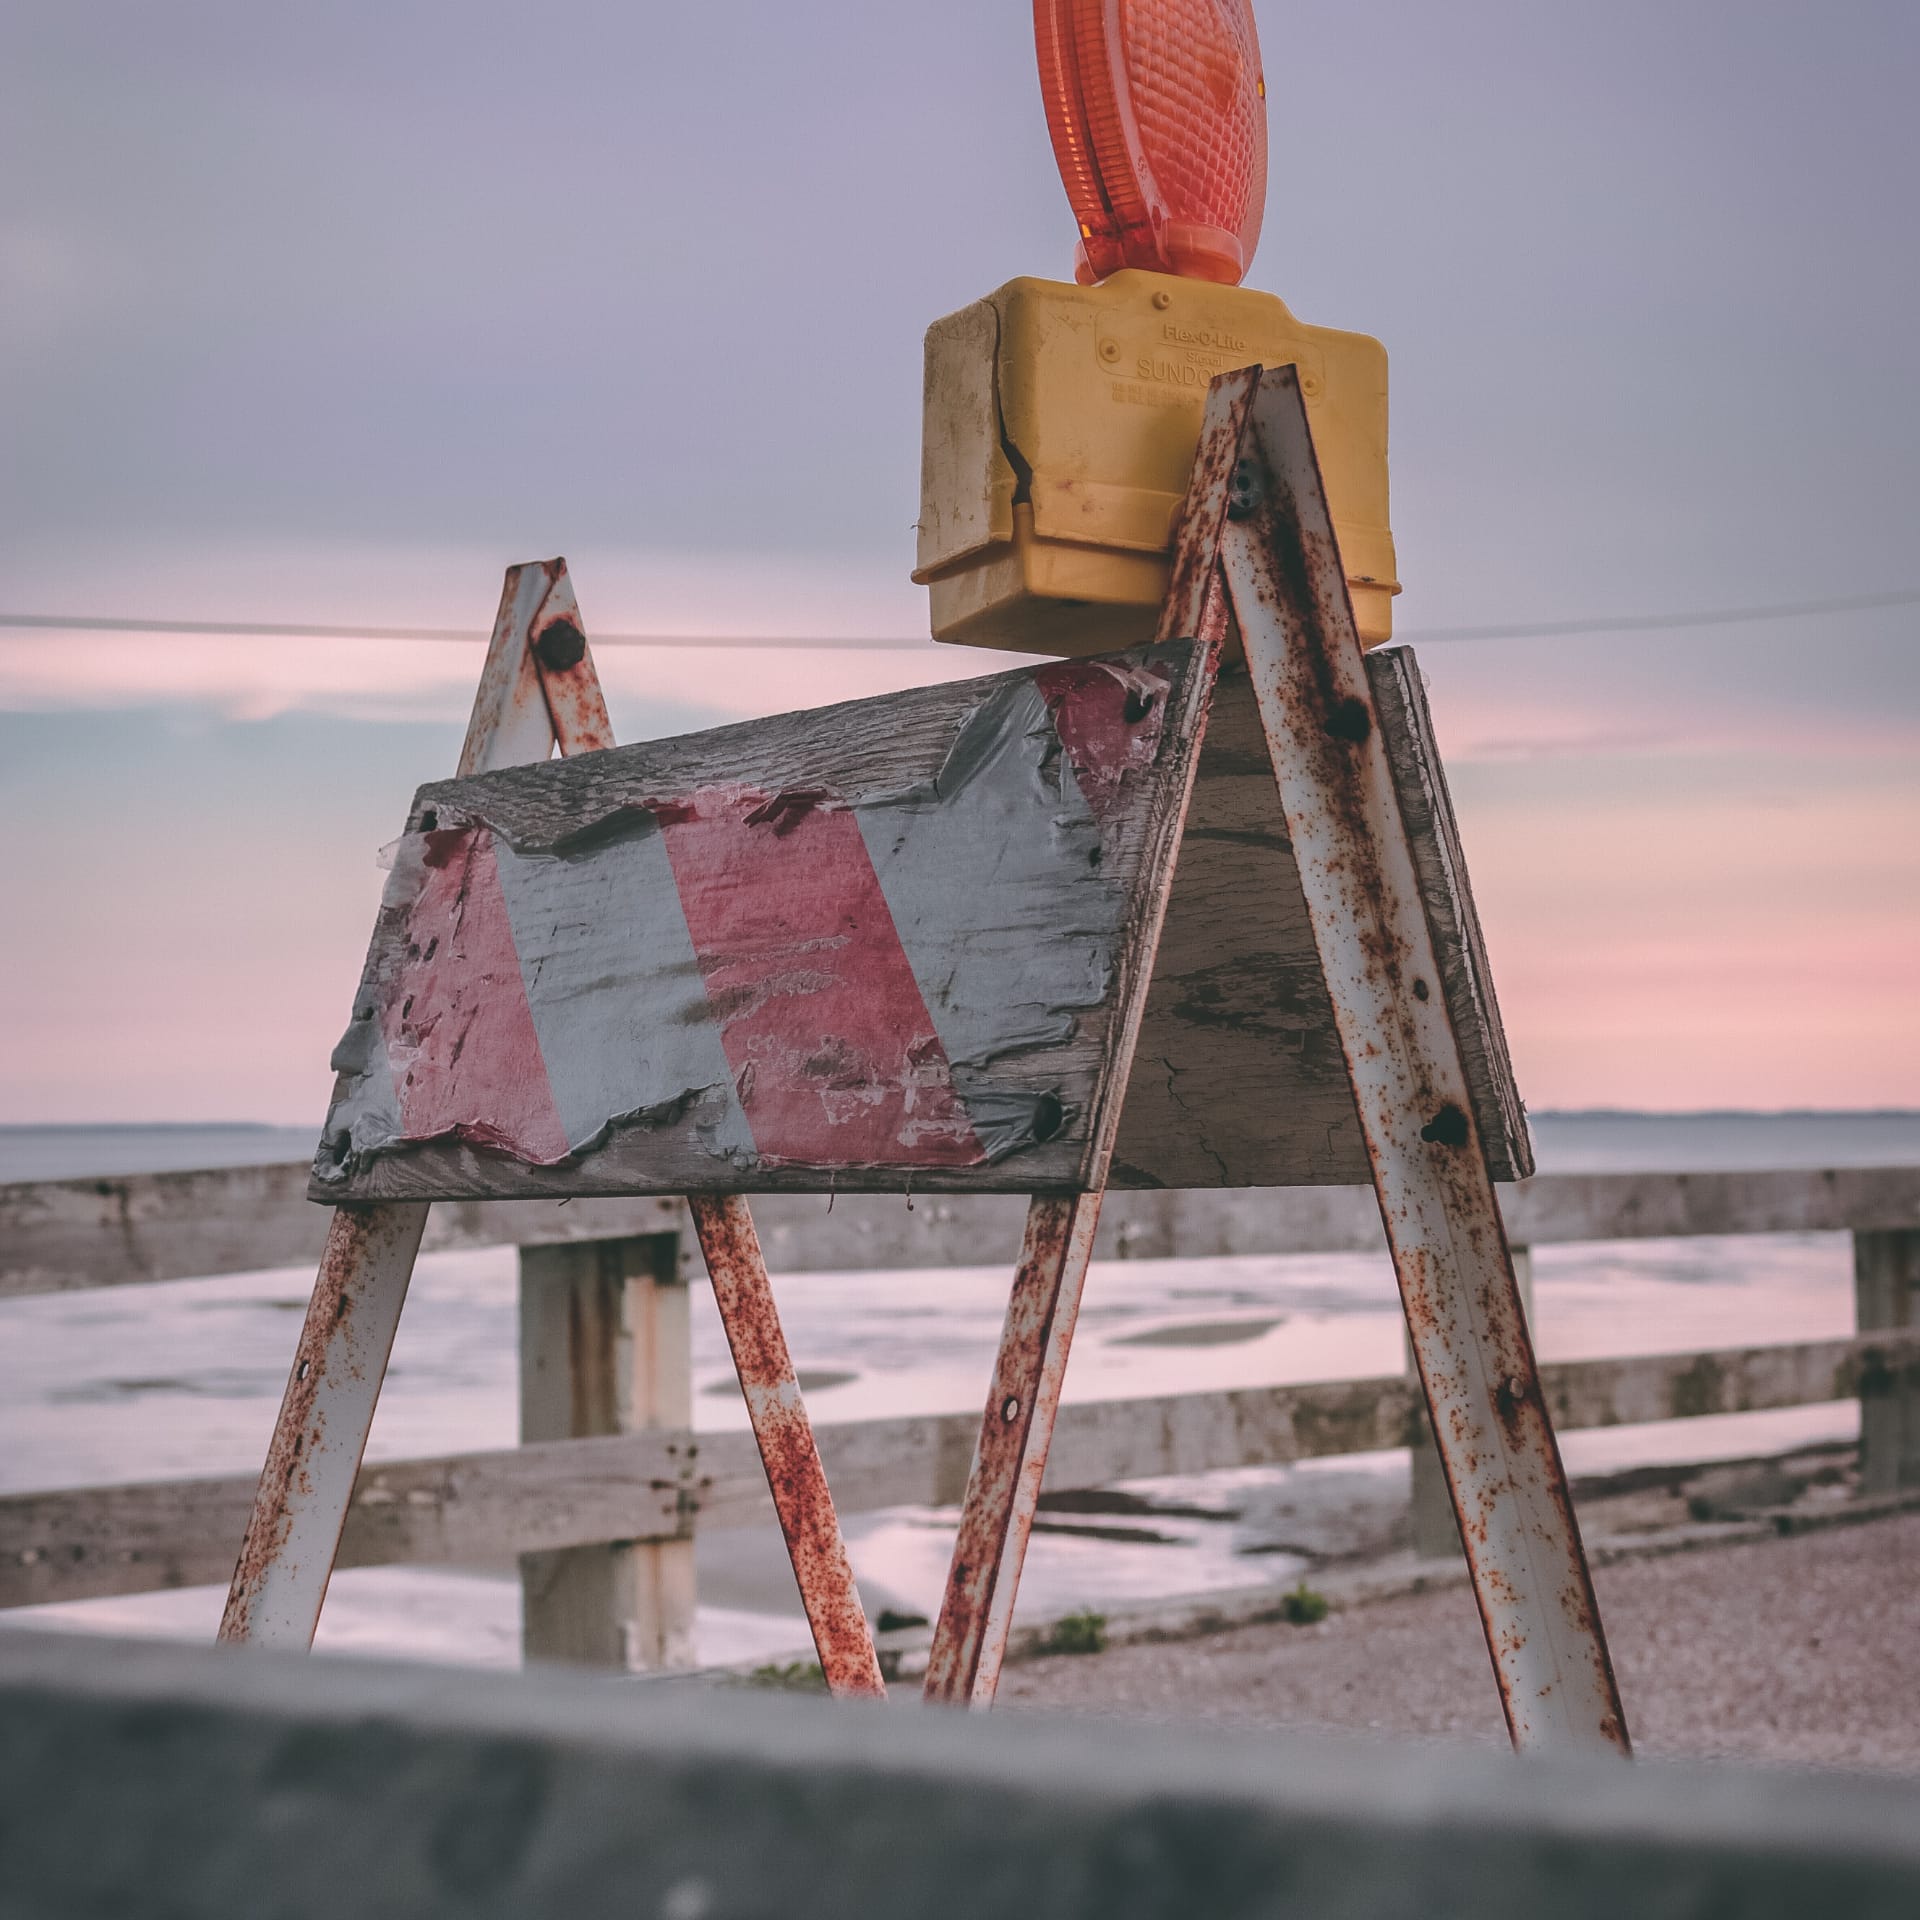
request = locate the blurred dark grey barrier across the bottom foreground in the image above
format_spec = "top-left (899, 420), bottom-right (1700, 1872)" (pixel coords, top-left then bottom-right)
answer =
top-left (0, 1630), bottom-right (1920, 1920)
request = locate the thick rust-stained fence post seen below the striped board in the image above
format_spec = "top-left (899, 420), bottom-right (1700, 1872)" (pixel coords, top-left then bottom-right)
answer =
top-left (520, 1233), bottom-right (695, 1670)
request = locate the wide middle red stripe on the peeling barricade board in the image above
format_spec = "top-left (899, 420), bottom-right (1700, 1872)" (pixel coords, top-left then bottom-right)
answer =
top-left (655, 789), bottom-right (985, 1167)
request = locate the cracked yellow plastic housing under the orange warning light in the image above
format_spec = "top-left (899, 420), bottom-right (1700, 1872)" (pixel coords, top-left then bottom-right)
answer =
top-left (914, 271), bottom-right (1400, 655)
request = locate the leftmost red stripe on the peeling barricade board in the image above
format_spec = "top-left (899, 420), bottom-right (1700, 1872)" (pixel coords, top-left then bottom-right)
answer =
top-left (380, 828), bottom-right (566, 1167)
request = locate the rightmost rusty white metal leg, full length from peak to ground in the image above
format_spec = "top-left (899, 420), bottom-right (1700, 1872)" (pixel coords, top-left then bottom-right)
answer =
top-left (1221, 367), bottom-right (1626, 1751)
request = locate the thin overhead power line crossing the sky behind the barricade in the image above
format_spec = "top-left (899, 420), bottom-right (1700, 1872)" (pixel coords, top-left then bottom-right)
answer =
top-left (0, 588), bottom-right (1920, 653)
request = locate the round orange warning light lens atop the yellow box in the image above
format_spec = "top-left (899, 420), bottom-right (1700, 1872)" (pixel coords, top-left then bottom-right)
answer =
top-left (1033, 0), bottom-right (1267, 286)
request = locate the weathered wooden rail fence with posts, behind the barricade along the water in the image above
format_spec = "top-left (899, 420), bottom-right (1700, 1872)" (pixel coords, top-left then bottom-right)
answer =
top-left (0, 1165), bottom-right (1920, 1667)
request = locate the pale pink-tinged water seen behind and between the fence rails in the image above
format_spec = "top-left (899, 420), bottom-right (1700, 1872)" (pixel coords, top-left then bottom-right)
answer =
top-left (0, 1114), bottom-right (1920, 1665)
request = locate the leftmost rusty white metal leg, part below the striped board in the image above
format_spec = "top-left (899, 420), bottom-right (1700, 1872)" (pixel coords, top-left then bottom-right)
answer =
top-left (219, 1202), bottom-right (426, 1647)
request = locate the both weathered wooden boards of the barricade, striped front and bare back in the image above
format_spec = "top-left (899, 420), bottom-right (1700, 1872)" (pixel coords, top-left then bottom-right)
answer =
top-left (313, 641), bottom-right (1532, 1202)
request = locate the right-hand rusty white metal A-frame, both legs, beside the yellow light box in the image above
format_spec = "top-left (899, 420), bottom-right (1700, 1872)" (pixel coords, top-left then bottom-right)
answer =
top-left (927, 367), bottom-right (1628, 1751)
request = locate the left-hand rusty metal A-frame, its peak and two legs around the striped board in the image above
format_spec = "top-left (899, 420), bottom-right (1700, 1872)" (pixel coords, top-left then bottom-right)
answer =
top-left (219, 561), bottom-right (881, 1693)
